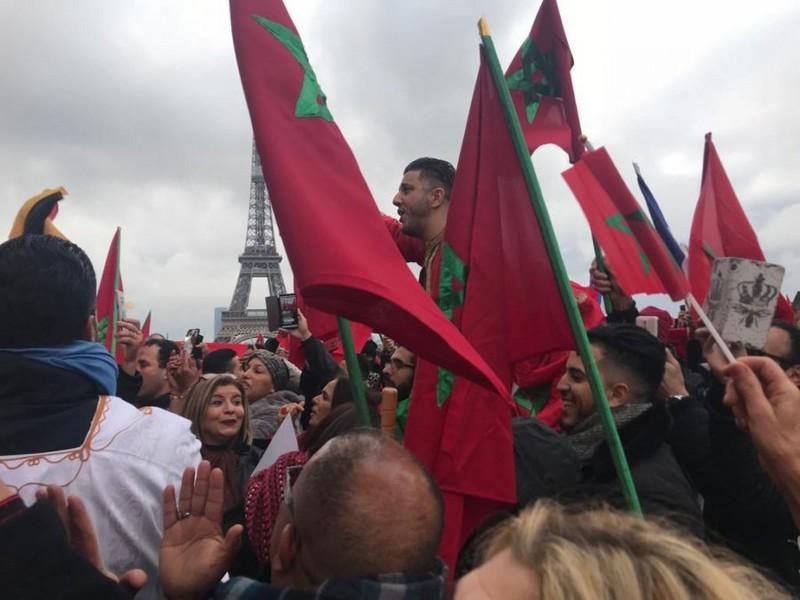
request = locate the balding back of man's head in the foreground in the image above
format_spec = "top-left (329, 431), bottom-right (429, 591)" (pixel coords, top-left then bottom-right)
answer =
top-left (293, 430), bottom-right (443, 578)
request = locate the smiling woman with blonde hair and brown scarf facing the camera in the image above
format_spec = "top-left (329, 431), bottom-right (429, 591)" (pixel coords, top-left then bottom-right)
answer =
top-left (182, 374), bottom-right (258, 511)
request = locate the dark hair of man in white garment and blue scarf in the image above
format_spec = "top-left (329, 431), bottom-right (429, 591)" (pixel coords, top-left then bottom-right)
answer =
top-left (0, 234), bottom-right (97, 348)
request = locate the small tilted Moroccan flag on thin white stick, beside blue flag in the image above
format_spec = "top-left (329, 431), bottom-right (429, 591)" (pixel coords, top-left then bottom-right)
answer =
top-left (562, 148), bottom-right (688, 301)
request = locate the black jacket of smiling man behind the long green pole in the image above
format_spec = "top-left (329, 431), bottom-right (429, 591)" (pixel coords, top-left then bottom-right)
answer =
top-left (514, 403), bottom-right (703, 534)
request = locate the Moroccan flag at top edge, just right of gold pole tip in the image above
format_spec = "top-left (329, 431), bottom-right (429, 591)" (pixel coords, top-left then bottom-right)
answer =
top-left (506, 0), bottom-right (585, 162)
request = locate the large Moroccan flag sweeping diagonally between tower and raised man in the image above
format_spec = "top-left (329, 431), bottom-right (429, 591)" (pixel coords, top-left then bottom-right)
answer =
top-left (230, 0), bottom-right (502, 396)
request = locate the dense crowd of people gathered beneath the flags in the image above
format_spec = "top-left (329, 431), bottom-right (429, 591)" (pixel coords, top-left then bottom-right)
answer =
top-left (0, 158), bottom-right (800, 600)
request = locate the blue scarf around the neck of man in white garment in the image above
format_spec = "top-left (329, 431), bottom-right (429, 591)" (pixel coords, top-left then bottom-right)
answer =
top-left (0, 341), bottom-right (118, 396)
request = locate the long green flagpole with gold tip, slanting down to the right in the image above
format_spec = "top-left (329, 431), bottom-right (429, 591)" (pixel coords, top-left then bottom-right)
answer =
top-left (478, 18), bottom-right (642, 515)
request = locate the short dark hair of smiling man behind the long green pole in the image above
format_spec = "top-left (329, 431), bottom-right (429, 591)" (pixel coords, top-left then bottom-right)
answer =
top-left (586, 323), bottom-right (666, 401)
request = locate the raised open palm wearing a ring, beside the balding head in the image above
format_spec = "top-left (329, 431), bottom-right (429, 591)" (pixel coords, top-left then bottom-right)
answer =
top-left (159, 460), bottom-right (244, 600)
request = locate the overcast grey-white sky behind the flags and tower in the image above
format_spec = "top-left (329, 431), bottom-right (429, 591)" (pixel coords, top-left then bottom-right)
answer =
top-left (0, 0), bottom-right (800, 337)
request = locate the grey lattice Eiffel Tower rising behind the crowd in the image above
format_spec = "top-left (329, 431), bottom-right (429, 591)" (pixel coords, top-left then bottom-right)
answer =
top-left (215, 141), bottom-right (286, 343)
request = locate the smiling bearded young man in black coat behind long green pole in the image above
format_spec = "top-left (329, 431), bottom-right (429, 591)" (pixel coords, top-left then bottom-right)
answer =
top-left (515, 324), bottom-right (702, 533)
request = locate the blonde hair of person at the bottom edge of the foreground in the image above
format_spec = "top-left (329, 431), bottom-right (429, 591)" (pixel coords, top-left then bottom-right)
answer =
top-left (486, 501), bottom-right (790, 600)
